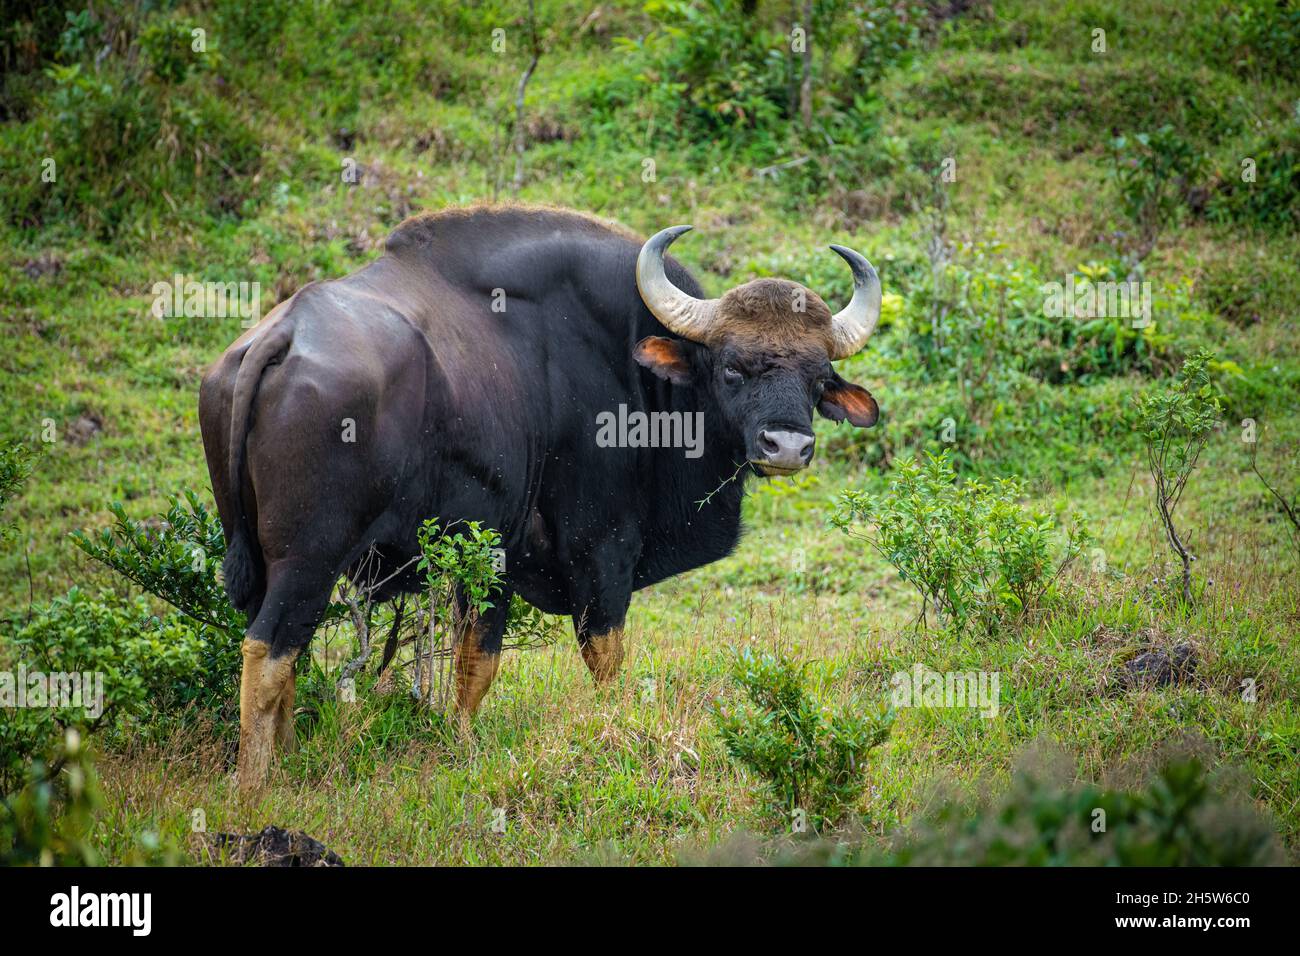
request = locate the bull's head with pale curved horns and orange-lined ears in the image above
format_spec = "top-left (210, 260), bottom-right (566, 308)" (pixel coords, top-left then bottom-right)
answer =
top-left (636, 226), bottom-right (880, 475)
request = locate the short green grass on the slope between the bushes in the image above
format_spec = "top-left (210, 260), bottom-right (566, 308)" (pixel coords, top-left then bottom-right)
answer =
top-left (0, 0), bottom-right (1300, 864)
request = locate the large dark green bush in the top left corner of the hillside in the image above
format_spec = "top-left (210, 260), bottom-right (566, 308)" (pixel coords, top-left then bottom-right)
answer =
top-left (0, 5), bottom-right (261, 238)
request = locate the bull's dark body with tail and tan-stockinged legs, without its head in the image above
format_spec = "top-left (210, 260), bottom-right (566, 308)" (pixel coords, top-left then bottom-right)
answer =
top-left (199, 207), bottom-right (874, 786)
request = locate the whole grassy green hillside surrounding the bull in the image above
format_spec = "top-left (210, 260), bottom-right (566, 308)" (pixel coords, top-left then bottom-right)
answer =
top-left (0, 0), bottom-right (1300, 862)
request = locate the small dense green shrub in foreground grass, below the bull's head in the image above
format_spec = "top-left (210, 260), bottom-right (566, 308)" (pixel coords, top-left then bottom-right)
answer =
top-left (714, 649), bottom-right (892, 830)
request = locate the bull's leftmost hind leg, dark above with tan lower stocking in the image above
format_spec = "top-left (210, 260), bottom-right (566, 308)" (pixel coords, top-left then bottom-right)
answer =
top-left (235, 562), bottom-right (334, 791)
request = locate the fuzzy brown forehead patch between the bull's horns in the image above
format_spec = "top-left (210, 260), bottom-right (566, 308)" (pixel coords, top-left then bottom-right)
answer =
top-left (714, 278), bottom-right (831, 354)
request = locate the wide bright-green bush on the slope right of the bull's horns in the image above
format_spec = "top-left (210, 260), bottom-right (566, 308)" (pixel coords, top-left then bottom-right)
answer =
top-left (816, 232), bottom-right (1232, 481)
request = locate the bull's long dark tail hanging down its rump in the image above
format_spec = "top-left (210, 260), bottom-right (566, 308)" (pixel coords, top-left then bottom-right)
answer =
top-left (221, 319), bottom-right (294, 623)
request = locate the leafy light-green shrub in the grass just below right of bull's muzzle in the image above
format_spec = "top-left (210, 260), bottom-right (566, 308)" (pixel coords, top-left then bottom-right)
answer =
top-left (832, 451), bottom-right (1089, 632)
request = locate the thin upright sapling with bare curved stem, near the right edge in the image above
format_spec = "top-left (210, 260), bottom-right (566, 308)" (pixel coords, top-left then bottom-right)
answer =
top-left (1134, 350), bottom-right (1223, 604)
